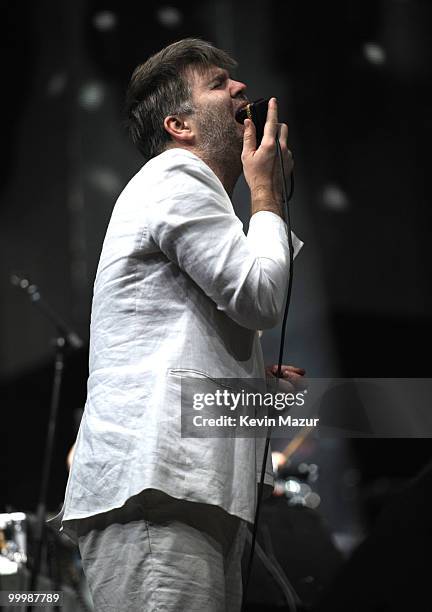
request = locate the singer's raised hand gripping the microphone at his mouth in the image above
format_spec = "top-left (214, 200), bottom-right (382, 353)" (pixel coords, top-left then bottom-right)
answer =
top-left (242, 98), bottom-right (293, 216)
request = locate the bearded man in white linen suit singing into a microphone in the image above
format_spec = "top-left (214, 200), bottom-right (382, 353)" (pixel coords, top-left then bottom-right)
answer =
top-left (55, 39), bottom-right (304, 612)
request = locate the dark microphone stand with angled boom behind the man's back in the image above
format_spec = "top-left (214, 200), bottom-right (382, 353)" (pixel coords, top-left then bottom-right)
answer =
top-left (11, 274), bottom-right (83, 612)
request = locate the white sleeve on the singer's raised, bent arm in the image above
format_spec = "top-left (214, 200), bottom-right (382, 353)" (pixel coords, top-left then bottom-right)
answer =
top-left (148, 157), bottom-right (301, 329)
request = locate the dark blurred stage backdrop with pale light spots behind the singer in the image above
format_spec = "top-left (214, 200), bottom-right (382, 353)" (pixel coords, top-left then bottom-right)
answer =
top-left (0, 0), bottom-right (432, 609)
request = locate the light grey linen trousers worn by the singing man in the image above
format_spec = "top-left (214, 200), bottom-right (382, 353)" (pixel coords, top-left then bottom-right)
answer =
top-left (77, 491), bottom-right (246, 612)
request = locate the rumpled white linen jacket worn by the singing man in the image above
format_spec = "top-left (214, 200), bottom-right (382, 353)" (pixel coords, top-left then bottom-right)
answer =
top-left (56, 148), bottom-right (302, 534)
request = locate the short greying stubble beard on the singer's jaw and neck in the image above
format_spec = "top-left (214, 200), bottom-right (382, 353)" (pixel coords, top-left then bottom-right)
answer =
top-left (195, 106), bottom-right (243, 174)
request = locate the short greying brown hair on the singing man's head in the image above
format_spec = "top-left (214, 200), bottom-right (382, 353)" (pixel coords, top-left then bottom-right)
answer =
top-left (126, 38), bottom-right (237, 159)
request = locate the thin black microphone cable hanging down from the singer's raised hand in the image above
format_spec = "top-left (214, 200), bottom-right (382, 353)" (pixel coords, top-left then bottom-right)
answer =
top-left (242, 137), bottom-right (294, 612)
